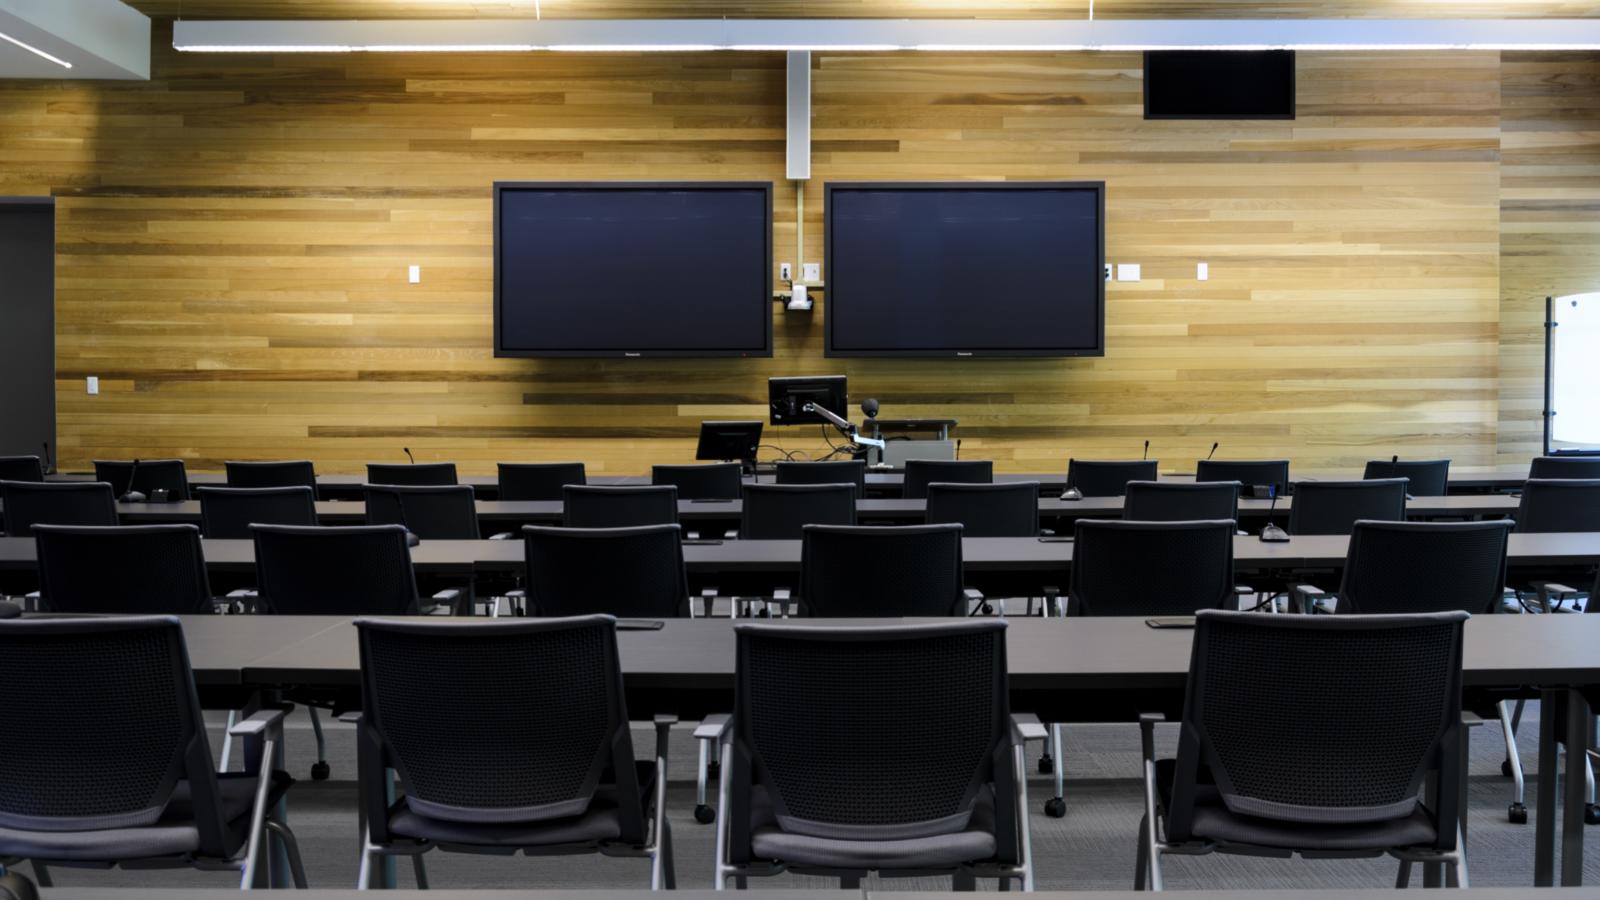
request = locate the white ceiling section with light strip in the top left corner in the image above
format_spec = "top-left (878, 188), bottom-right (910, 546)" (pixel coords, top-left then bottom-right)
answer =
top-left (0, 0), bottom-right (150, 80)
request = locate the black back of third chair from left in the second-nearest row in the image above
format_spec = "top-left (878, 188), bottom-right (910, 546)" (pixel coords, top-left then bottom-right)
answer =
top-left (522, 525), bottom-right (690, 618)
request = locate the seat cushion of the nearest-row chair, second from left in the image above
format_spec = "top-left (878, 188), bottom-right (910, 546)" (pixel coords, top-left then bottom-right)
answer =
top-left (389, 762), bottom-right (656, 847)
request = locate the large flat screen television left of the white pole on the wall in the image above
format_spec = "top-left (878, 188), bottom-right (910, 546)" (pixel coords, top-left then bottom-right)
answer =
top-left (494, 181), bottom-right (773, 357)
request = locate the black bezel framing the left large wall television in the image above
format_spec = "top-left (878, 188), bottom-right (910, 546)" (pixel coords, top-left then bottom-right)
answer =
top-left (493, 181), bottom-right (773, 359)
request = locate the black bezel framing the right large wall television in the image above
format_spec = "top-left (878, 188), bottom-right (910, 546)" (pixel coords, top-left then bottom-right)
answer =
top-left (822, 181), bottom-right (1106, 359)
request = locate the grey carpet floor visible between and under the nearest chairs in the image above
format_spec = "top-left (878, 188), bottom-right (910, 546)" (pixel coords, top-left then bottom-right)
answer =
top-left (25, 703), bottom-right (1600, 890)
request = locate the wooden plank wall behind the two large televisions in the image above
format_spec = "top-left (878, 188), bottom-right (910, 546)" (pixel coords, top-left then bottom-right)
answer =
top-left (0, 35), bottom-right (1574, 472)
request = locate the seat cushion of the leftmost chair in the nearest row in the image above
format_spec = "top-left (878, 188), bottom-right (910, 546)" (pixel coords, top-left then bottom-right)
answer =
top-left (0, 772), bottom-right (294, 862)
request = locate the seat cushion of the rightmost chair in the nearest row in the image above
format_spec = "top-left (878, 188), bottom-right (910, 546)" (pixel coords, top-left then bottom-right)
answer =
top-left (1155, 759), bottom-right (1438, 852)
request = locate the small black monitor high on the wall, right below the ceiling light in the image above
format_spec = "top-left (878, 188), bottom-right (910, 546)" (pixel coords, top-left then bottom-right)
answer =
top-left (1144, 50), bottom-right (1294, 119)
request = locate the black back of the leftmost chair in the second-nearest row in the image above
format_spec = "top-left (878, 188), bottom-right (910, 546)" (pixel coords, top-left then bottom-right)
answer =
top-left (34, 524), bottom-right (211, 615)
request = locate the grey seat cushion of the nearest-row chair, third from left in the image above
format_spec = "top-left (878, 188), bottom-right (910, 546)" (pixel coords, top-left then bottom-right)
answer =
top-left (750, 785), bottom-right (995, 870)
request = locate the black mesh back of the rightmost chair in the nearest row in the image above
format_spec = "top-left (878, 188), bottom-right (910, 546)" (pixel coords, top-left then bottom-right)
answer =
top-left (1166, 610), bottom-right (1467, 846)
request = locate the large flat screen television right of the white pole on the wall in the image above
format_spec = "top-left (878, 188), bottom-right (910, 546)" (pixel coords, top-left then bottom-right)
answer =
top-left (824, 181), bottom-right (1106, 357)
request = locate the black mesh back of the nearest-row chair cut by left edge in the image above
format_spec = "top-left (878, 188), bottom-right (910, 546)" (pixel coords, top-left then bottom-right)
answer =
top-left (0, 617), bottom-right (243, 857)
